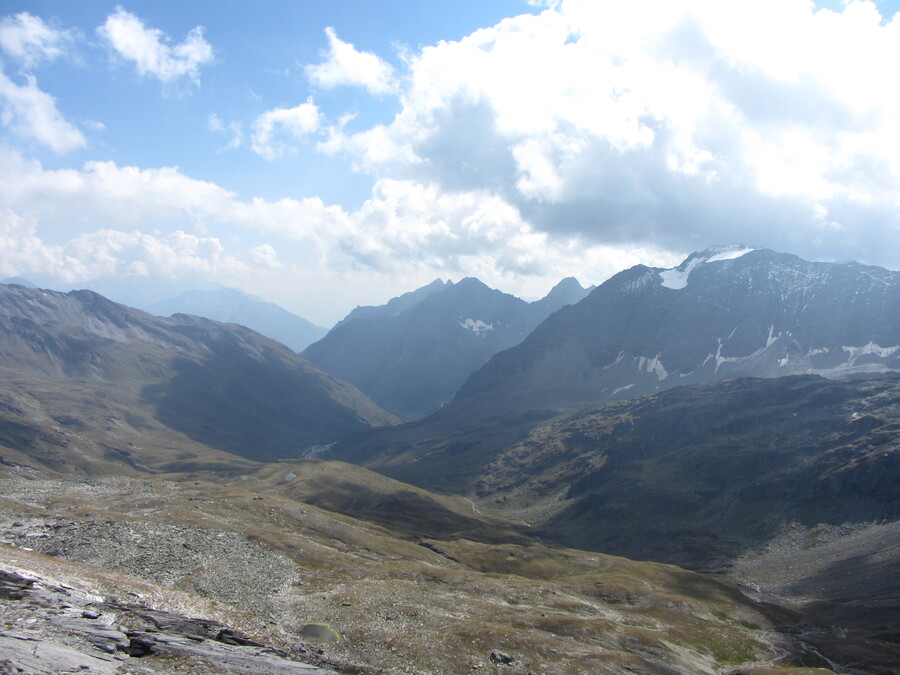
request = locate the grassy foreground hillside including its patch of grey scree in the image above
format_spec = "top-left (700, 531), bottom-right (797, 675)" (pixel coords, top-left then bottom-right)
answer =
top-left (0, 465), bottom-right (876, 673)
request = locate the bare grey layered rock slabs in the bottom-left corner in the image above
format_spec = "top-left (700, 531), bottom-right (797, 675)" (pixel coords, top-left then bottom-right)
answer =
top-left (0, 544), bottom-right (333, 675)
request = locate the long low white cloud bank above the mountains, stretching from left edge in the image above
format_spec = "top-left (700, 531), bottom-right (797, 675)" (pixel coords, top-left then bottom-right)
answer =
top-left (0, 149), bottom-right (680, 323)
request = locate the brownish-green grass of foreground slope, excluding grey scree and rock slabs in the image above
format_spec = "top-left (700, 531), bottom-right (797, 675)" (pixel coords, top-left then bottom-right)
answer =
top-left (0, 476), bottom-right (836, 673)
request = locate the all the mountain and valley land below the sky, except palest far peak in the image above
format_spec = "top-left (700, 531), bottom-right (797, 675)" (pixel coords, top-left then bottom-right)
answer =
top-left (0, 247), bottom-right (900, 675)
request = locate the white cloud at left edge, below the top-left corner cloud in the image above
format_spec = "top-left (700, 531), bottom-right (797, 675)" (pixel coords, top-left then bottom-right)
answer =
top-left (0, 72), bottom-right (87, 153)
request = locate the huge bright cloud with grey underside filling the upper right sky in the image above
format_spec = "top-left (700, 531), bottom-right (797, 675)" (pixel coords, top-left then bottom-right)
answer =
top-left (319, 0), bottom-right (900, 264)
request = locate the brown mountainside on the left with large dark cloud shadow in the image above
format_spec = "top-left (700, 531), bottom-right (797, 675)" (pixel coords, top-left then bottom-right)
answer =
top-left (0, 286), bottom-right (396, 472)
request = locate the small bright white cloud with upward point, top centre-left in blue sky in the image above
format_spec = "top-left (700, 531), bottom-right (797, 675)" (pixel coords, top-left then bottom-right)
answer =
top-left (305, 27), bottom-right (396, 94)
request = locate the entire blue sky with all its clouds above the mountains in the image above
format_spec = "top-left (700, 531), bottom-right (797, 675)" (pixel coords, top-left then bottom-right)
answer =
top-left (0, 0), bottom-right (900, 326)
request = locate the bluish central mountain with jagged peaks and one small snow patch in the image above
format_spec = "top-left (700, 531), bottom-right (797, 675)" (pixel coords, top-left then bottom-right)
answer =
top-left (303, 278), bottom-right (587, 419)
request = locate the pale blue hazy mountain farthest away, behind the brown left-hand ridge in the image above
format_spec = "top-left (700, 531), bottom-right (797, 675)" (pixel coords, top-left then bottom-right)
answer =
top-left (146, 288), bottom-right (328, 352)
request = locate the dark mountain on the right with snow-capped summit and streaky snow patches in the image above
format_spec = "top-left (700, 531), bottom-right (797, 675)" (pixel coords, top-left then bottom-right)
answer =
top-left (453, 246), bottom-right (900, 412)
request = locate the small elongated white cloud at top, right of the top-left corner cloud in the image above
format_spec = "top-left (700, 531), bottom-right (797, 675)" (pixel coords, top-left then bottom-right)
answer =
top-left (97, 7), bottom-right (213, 84)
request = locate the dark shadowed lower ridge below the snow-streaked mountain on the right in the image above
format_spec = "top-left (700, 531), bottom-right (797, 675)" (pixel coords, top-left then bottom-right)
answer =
top-left (328, 373), bottom-right (900, 569)
